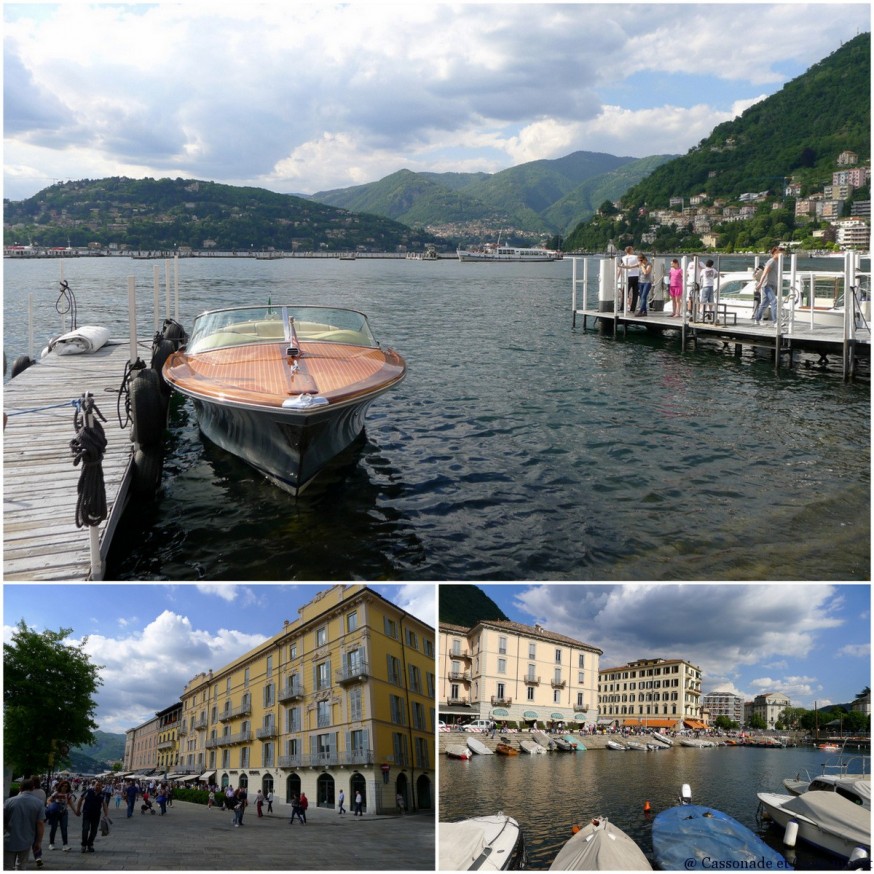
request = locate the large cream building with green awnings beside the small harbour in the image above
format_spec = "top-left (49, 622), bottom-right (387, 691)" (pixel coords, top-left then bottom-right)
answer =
top-left (440, 619), bottom-right (602, 727)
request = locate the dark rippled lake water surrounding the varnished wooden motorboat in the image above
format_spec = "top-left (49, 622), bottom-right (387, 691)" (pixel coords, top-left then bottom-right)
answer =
top-left (4, 258), bottom-right (870, 581)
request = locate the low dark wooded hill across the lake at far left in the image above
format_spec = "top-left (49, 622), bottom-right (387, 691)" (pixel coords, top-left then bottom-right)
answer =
top-left (3, 177), bottom-right (445, 252)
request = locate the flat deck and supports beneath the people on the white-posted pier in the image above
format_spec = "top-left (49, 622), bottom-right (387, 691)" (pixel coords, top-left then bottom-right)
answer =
top-left (573, 308), bottom-right (871, 380)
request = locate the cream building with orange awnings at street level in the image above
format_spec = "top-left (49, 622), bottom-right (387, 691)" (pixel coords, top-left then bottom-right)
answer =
top-left (598, 658), bottom-right (706, 729)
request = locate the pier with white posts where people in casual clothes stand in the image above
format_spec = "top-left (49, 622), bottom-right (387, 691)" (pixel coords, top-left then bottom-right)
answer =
top-left (571, 250), bottom-right (871, 382)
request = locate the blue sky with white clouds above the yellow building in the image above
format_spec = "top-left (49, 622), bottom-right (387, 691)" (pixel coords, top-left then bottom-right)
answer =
top-left (3, 583), bottom-right (436, 732)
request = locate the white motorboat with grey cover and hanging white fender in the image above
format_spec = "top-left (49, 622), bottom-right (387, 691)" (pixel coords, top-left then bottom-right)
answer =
top-left (758, 790), bottom-right (871, 859)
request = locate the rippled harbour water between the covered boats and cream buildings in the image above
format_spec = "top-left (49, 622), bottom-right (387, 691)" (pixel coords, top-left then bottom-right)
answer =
top-left (439, 747), bottom-right (860, 871)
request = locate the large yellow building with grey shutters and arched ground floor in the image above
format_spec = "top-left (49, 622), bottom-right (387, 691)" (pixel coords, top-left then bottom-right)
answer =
top-left (177, 585), bottom-right (436, 813)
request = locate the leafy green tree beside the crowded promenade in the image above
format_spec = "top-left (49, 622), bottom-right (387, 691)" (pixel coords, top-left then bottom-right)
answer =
top-left (3, 619), bottom-right (103, 774)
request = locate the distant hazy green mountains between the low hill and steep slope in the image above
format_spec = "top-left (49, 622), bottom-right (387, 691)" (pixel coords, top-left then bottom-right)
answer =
top-left (311, 152), bottom-right (673, 241)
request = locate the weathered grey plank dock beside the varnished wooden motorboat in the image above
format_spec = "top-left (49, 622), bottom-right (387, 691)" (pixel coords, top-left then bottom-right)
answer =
top-left (3, 342), bottom-right (138, 582)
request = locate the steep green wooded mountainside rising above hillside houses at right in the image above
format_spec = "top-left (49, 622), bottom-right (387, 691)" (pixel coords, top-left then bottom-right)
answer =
top-left (565, 33), bottom-right (871, 251)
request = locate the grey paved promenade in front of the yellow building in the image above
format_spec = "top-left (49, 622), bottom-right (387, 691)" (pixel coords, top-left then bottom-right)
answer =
top-left (35, 801), bottom-right (435, 872)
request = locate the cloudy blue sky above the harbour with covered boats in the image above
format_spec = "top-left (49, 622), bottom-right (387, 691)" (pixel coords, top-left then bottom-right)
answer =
top-left (466, 583), bottom-right (871, 708)
